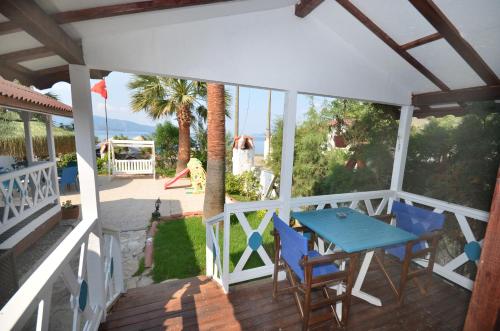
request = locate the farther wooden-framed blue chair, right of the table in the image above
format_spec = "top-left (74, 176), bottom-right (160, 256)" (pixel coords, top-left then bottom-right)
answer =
top-left (375, 201), bottom-right (445, 304)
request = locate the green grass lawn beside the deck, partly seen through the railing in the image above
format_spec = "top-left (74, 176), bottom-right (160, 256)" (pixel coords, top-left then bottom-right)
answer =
top-left (152, 212), bottom-right (274, 282)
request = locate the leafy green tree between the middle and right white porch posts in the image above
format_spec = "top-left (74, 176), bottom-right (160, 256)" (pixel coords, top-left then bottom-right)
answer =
top-left (268, 100), bottom-right (398, 196)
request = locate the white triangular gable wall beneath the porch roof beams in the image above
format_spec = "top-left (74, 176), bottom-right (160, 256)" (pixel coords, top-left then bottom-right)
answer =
top-left (83, 3), bottom-right (427, 104)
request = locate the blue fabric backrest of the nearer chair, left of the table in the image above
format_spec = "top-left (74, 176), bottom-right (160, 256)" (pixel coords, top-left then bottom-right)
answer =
top-left (273, 214), bottom-right (308, 277)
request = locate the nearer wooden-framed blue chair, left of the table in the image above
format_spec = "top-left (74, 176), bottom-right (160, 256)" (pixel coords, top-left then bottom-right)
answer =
top-left (273, 214), bottom-right (357, 330)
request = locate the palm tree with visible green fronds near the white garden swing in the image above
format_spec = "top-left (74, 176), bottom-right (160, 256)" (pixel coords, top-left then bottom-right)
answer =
top-left (128, 75), bottom-right (207, 173)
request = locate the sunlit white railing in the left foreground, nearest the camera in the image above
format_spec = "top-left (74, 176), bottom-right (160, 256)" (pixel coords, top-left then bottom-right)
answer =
top-left (0, 219), bottom-right (124, 330)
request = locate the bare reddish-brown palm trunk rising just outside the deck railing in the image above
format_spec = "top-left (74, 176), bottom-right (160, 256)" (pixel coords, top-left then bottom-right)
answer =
top-left (203, 83), bottom-right (226, 219)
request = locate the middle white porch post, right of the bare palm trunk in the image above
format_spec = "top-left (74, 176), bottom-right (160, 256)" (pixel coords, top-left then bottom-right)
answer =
top-left (280, 91), bottom-right (297, 222)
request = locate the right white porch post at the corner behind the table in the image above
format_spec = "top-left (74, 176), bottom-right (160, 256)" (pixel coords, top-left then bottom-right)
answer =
top-left (387, 106), bottom-right (413, 212)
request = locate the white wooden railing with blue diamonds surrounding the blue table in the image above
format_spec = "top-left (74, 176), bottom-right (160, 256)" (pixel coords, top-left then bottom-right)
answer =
top-left (206, 190), bottom-right (488, 292)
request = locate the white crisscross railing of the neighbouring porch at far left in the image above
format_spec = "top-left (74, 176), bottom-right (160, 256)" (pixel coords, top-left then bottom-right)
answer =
top-left (0, 162), bottom-right (59, 233)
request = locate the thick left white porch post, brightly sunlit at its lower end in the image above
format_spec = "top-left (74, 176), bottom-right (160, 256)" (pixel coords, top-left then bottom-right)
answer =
top-left (69, 64), bottom-right (99, 219)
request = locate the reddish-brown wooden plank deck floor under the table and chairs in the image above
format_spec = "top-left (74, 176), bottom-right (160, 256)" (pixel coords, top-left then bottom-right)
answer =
top-left (101, 265), bottom-right (470, 331)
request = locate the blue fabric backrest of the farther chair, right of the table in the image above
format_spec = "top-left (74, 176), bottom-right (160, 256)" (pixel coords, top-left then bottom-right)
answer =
top-left (392, 201), bottom-right (444, 236)
